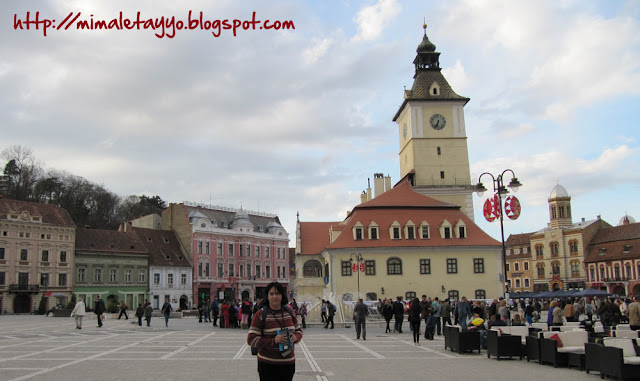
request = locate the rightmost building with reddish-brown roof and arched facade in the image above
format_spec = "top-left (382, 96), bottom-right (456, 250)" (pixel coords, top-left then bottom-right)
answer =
top-left (585, 216), bottom-right (640, 296)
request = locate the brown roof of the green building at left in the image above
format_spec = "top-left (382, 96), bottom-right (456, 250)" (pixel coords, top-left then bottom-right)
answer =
top-left (76, 228), bottom-right (148, 254)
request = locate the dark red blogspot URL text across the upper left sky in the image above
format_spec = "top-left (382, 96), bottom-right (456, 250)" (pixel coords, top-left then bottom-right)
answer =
top-left (13, 11), bottom-right (296, 38)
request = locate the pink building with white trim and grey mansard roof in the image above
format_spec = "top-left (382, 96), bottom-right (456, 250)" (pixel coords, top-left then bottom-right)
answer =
top-left (162, 203), bottom-right (290, 302)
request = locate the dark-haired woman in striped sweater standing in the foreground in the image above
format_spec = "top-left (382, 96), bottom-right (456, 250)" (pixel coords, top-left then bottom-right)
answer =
top-left (247, 282), bottom-right (302, 381)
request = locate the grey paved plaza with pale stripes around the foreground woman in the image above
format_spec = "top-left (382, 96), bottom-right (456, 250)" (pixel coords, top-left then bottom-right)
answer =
top-left (0, 315), bottom-right (600, 381)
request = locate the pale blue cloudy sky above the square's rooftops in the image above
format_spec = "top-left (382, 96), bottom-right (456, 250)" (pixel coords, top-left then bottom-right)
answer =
top-left (0, 0), bottom-right (640, 247)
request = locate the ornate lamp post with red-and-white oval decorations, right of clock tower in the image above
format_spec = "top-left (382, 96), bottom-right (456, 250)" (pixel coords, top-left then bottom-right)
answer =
top-left (475, 169), bottom-right (522, 299)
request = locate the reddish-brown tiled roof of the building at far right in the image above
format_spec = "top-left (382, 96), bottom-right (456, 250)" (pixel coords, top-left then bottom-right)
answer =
top-left (584, 223), bottom-right (640, 262)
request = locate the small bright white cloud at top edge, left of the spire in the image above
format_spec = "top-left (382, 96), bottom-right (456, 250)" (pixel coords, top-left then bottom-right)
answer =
top-left (353, 0), bottom-right (402, 41)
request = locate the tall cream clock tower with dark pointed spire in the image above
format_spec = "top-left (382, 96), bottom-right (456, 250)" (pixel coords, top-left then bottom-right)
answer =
top-left (393, 24), bottom-right (473, 220)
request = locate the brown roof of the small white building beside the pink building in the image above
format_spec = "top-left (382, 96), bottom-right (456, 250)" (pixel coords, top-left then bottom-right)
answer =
top-left (133, 228), bottom-right (191, 267)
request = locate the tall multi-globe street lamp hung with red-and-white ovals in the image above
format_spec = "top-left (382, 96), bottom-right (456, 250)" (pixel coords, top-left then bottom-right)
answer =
top-left (475, 169), bottom-right (522, 298)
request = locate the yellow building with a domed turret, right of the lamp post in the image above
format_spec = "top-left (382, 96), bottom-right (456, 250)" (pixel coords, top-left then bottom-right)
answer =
top-left (529, 185), bottom-right (611, 291)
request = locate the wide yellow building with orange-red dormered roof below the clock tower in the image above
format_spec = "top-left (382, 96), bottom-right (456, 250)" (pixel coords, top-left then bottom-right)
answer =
top-left (295, 180), bottom-right (502, 302)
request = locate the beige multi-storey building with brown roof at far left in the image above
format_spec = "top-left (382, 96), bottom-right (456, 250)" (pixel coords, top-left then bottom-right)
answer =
top-left (0, 198), bottom-right (76, 313)
